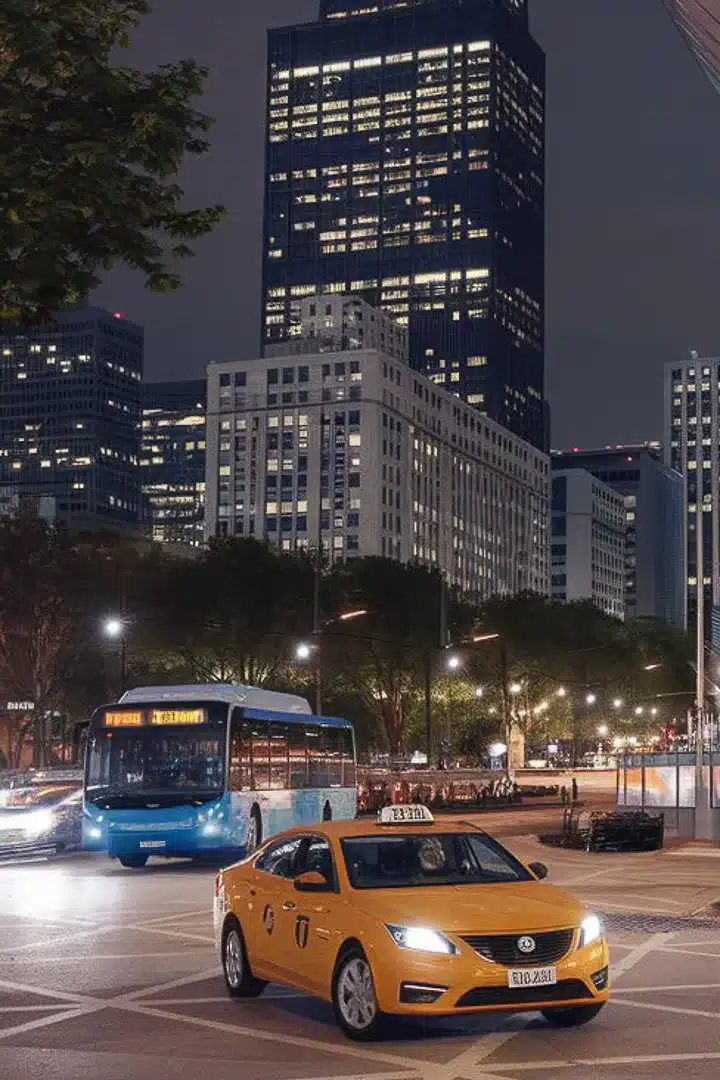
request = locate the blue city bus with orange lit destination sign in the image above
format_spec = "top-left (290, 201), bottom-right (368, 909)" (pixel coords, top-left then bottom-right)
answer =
top-left (83, 683), bottom-right (357, 867)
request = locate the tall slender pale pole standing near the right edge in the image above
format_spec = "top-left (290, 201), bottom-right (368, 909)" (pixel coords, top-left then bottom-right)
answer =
top-left (690, 351), bottom-right (711, 840)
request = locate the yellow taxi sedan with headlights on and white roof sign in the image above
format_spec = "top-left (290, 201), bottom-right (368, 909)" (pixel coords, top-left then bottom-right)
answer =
top-left (215, 806), bottom-right (610, 1039)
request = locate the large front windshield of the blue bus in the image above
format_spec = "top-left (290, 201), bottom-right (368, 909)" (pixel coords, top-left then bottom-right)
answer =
top-left (85, 724), bottom-right (226, 805)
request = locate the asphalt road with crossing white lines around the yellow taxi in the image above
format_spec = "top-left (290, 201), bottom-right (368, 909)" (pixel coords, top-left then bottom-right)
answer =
top-left (0, 811), bottom-right (720, 1080)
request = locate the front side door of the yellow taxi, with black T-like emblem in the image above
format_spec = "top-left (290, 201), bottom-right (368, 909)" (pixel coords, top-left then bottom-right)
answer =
top-left (279, 836), bottom-right (342, 996)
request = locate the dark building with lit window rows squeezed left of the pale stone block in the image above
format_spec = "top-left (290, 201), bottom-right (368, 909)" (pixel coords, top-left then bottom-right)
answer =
top-left (140, 379), bottom-right (205, 548)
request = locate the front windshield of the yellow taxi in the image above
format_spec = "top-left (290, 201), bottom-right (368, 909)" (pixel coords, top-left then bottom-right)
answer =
top-left (341, 833), bottom-right (533, 889)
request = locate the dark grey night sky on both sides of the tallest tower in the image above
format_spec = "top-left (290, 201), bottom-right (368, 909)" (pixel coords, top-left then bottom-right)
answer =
top-left (94, 0), bottom-right (720, 447)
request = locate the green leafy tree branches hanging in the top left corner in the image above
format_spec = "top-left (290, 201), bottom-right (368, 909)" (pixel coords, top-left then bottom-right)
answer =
top-left (0, 0), bottom-right (223, 323)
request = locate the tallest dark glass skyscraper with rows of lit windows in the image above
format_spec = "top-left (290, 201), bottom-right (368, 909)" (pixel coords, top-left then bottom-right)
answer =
top-left (262, 0), bottom-right (547, 448)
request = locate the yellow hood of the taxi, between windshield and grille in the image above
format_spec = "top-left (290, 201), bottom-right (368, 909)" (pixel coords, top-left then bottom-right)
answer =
top-left (353, 881), bottom-right (587, 933)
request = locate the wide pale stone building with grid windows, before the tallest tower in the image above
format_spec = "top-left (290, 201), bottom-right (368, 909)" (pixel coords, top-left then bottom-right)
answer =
top-left (205, 300), bottom-right (549, 597)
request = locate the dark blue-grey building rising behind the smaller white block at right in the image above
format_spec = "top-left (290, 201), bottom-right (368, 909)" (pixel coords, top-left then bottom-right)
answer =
top-left (552, 443), bottom-right (685, 630)
